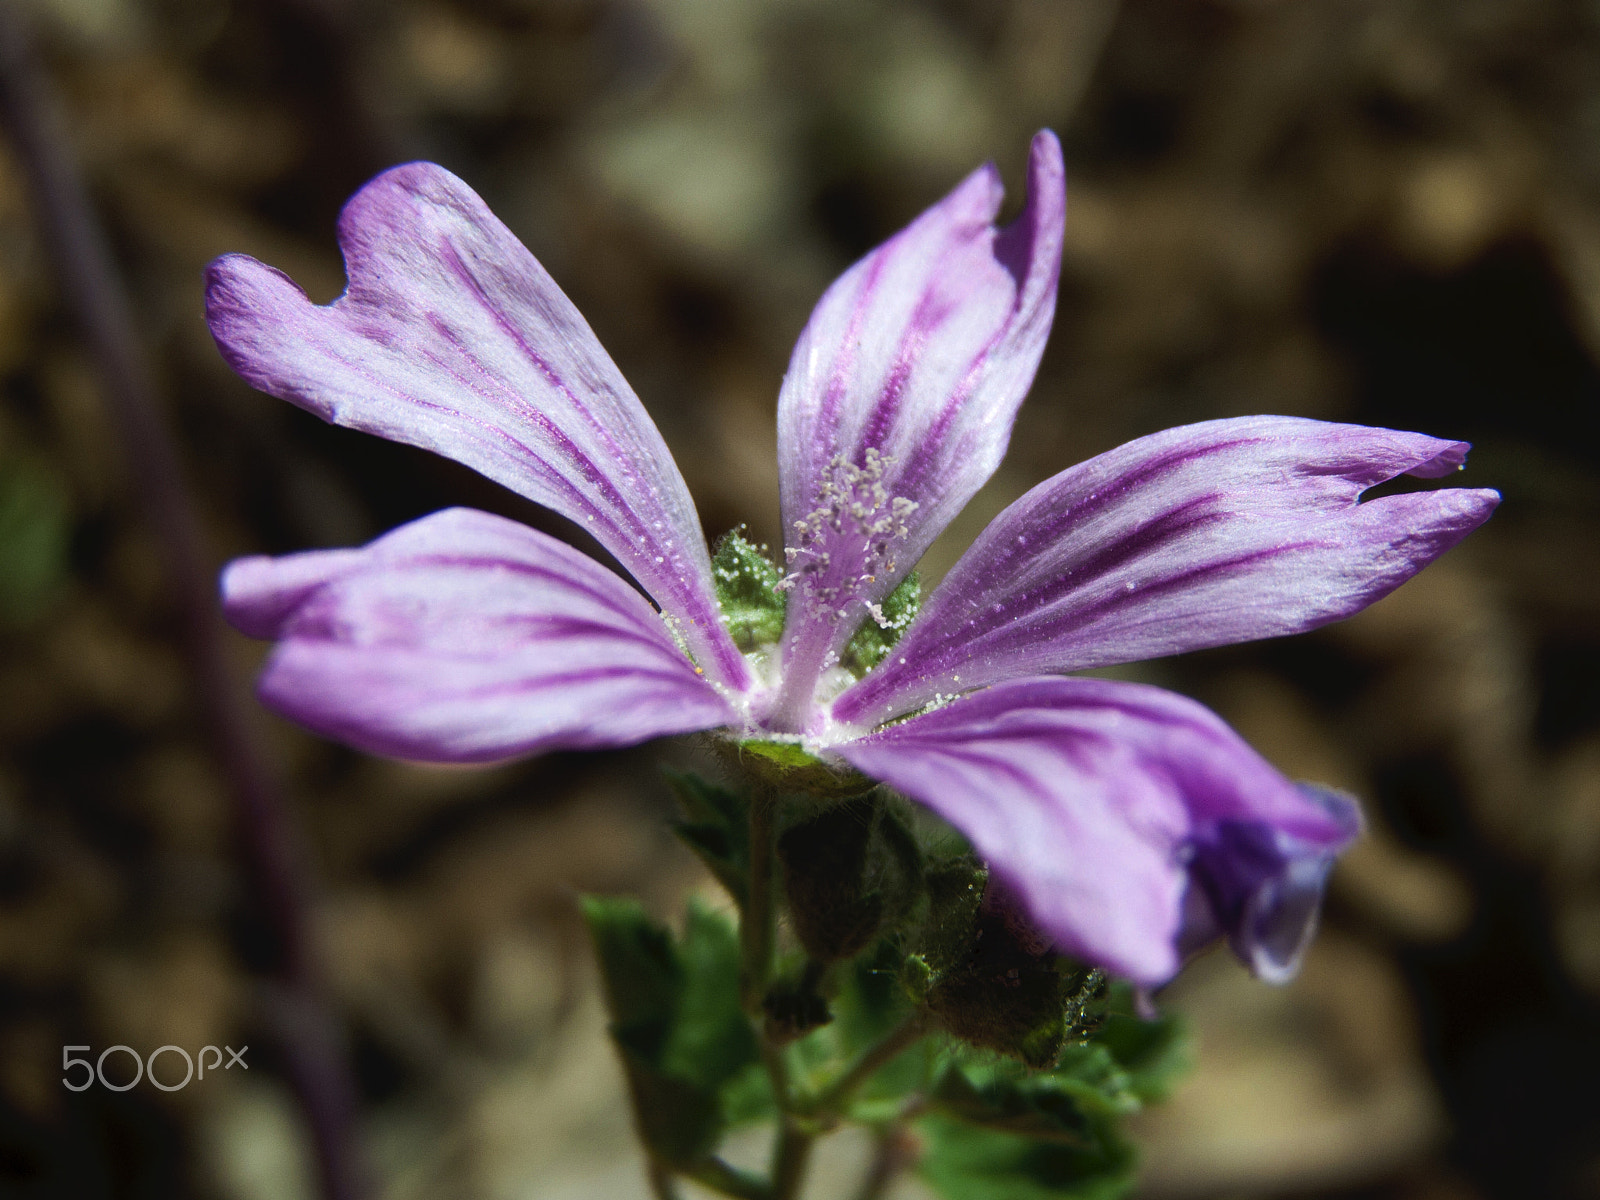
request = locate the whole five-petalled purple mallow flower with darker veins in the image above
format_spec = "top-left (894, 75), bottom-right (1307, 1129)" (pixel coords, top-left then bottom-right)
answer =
top-left (206, 131), bottom-right (1499, 984)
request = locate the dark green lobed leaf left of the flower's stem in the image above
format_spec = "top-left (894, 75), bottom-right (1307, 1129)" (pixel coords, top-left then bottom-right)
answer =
top-left (582, 896), bottom-right (760, 1166)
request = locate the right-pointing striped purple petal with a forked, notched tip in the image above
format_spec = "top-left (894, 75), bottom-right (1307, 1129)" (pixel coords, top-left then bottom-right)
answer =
top-left (834, 416), bottom-right (1499, 728)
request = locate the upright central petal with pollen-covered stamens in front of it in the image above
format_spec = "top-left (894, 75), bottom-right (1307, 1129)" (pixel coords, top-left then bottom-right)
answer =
top-left (778, 130), bottom-right (1066, 729)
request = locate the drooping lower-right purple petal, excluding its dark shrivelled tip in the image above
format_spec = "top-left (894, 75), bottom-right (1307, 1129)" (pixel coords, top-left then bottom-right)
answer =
top-left (830, 678), bottom-right (1354, 986)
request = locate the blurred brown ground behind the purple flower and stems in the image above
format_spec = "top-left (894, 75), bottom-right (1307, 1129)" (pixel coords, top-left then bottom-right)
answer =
top-left (0, 0), bottom-right (1600, 1200)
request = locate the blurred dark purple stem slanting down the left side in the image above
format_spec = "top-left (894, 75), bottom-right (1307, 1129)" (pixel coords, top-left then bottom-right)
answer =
top-left (0, 11), bottom-right (366, 1200)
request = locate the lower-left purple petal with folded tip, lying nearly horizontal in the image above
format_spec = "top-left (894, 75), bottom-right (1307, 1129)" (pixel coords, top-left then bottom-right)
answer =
top-left (222, 509), bottom-right (733, 762)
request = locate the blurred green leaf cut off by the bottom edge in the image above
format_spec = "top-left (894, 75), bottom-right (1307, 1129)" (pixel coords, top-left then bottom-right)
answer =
top-left (917, 1115), bottom-right (1134, 1200)
